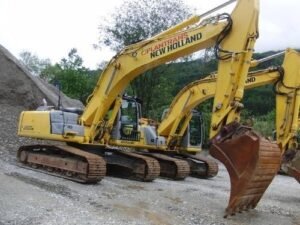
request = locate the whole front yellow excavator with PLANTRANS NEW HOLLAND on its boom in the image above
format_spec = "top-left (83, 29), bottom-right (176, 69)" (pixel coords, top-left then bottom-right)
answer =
top-left (18, 0), bottom-right (288, 214)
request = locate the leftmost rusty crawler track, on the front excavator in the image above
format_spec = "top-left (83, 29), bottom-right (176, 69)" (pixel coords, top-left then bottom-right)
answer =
top-left (17, 145), bottom-right (106, 183)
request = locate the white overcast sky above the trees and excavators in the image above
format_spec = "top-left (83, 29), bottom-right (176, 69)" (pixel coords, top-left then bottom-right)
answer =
top-left (0, 0), bottom-right (300, 68)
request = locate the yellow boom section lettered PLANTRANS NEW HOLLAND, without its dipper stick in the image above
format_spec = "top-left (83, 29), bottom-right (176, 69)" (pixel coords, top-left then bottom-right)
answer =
top-left (80, 18), bottom-right (228, 141)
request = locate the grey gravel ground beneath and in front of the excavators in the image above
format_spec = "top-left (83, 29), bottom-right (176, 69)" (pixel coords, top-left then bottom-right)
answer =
top-left (0, 104), bottom-right (300, 225)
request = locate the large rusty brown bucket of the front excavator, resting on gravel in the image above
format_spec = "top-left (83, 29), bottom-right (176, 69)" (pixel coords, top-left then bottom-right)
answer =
top-left (210, 122), bottom-right (281, 217)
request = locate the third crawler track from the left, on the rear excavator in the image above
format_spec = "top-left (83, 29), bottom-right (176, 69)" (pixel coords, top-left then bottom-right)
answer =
top-left (141, 153), bottom-right (190, 180)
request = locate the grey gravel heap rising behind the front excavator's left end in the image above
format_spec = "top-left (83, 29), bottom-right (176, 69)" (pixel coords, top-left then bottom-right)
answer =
top-left (0, 45), bottom-right (84, 159)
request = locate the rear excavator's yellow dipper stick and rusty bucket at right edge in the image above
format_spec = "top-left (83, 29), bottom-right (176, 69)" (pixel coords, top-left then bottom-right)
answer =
top-left (275, 51), bottom-right (300, 183)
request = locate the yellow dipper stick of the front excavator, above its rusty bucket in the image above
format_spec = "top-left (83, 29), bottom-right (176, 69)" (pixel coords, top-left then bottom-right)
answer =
top-left (210, 0), bottom-right (259, 138)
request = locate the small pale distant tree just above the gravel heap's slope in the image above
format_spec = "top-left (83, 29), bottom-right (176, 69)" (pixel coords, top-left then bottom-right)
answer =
top-left (19, 51), bottom-right (51, 76)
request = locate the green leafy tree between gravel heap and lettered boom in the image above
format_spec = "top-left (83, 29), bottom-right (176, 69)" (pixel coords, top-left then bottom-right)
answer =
top-left (41, 48), bottom-right (99, 102)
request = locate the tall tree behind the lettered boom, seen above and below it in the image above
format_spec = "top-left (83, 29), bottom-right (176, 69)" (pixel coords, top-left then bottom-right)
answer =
top-left (98, 0), bottom-right (191, 117)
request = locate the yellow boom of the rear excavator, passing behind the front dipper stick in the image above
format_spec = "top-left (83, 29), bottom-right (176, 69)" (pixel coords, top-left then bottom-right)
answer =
top-left (157, 67), bottom-right (280, 144)
